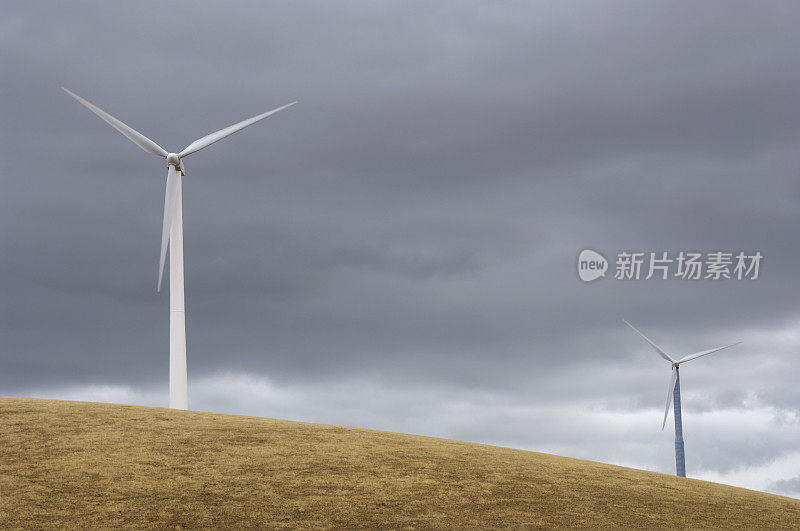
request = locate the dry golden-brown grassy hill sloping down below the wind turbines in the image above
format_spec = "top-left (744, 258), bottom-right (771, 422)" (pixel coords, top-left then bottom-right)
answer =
top-left (0, 398), bottom-right (800, 529)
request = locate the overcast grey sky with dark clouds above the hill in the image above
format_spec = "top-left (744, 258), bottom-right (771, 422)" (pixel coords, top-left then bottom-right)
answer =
top-left (0, 1), bottom-right (800, 497)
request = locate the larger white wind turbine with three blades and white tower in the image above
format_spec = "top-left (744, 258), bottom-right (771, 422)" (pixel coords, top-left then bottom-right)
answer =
top-left (61, 87), bottom-right (297, 409)
